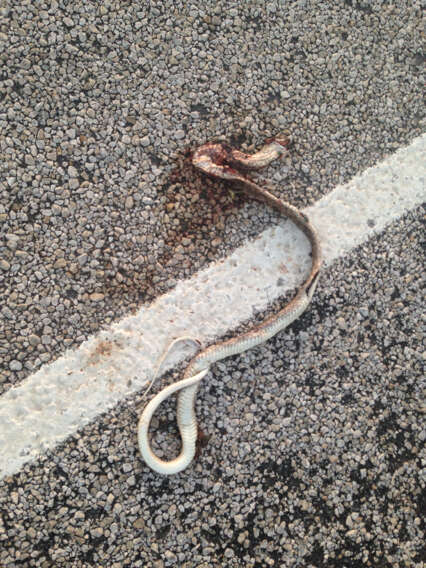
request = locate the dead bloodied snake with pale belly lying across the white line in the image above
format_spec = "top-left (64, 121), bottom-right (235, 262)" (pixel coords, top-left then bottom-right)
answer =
top-left (138, 133), bottom-right (322, 475)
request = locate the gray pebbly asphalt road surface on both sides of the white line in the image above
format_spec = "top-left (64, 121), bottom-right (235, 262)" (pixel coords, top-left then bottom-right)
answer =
top-left (0, 0), bottom-right (426, 568)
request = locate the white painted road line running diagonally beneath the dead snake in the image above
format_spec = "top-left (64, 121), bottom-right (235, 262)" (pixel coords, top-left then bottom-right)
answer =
top-left (0, 135), bottom-right (426, 477)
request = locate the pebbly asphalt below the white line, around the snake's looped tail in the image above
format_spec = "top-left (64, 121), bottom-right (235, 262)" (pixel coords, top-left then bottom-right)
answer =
top-left (0, 209), bottom-right (426, 568)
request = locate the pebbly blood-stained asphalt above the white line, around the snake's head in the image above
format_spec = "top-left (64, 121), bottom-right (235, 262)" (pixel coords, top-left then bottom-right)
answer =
top-left (0, 0), bottom-right (424, 392)
